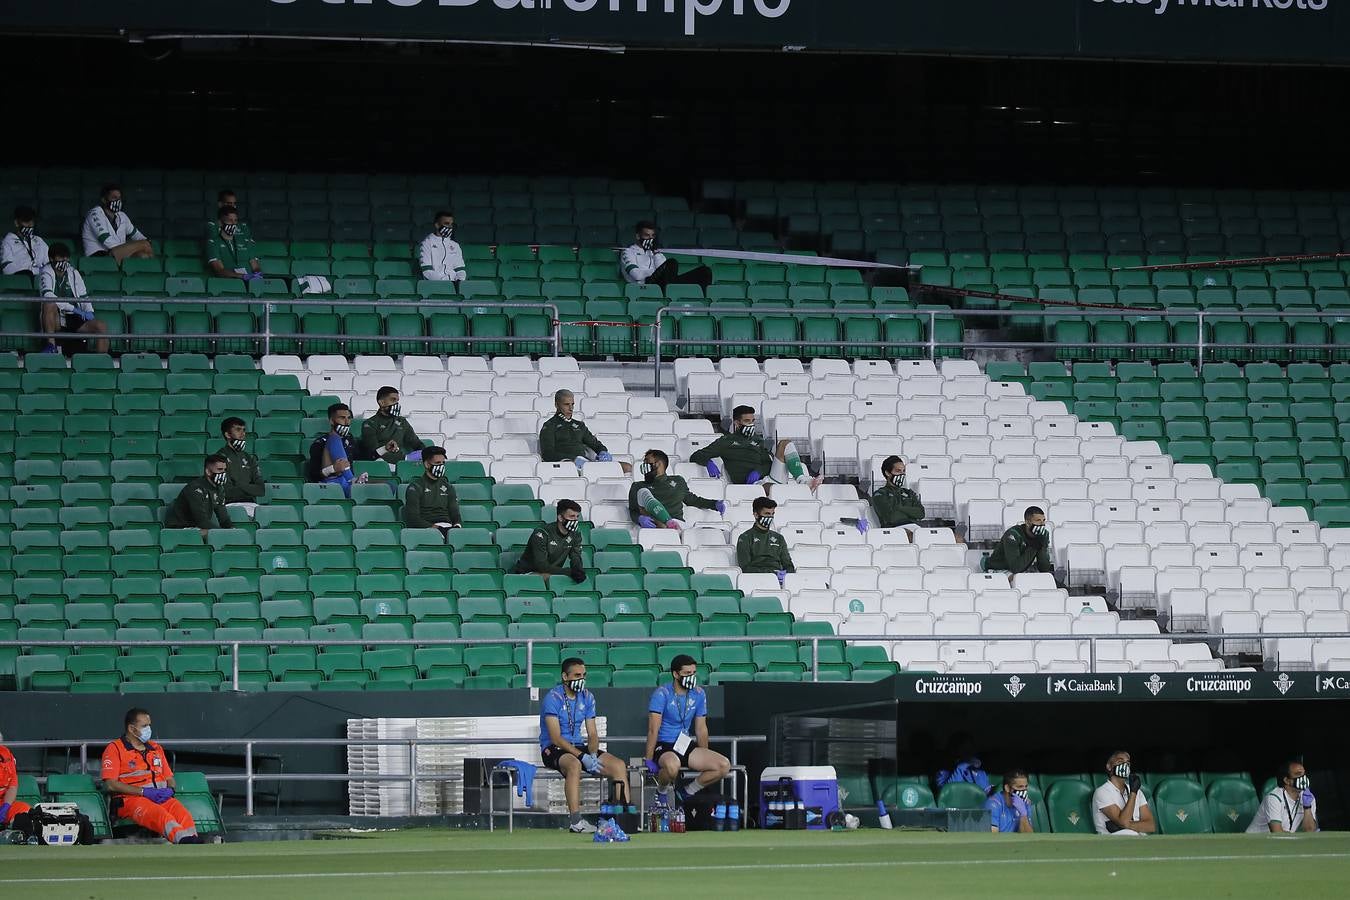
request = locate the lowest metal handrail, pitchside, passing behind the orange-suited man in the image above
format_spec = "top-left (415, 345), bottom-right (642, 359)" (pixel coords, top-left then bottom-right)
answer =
top-left (5, 733), bottom-right (768, 815)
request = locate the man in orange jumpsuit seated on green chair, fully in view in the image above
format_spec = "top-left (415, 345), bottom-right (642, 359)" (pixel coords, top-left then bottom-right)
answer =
top-left (103, 708), bottom-right (203, 843)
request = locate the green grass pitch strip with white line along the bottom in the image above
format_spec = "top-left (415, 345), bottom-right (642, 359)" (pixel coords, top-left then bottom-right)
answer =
top-left (0, 828), bottom-right (1350, 900)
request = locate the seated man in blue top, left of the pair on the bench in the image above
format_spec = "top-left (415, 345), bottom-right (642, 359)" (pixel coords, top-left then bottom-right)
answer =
top-left (539, 656), bottom-right (636, 834)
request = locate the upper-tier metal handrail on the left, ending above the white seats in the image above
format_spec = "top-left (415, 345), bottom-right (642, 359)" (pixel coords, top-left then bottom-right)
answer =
top-left (0, 294), bottom-right (563, 356)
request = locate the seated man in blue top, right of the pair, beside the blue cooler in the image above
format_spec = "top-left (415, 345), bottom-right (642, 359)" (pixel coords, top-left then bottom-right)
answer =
top-left (645, 653), bottom-right (732, 796)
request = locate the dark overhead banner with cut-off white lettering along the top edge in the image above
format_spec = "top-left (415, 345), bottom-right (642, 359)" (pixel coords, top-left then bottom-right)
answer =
top-left (0, 0), bottom-right (1350, 62)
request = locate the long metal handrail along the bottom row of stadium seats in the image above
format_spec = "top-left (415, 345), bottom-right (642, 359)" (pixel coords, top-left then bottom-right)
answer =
top-left (0, 631), bottom-right (1317, 691)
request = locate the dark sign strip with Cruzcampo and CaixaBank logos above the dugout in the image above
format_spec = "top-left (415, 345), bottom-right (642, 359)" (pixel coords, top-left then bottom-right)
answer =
top-left (895, 671), bottom-right (1350, 703)
